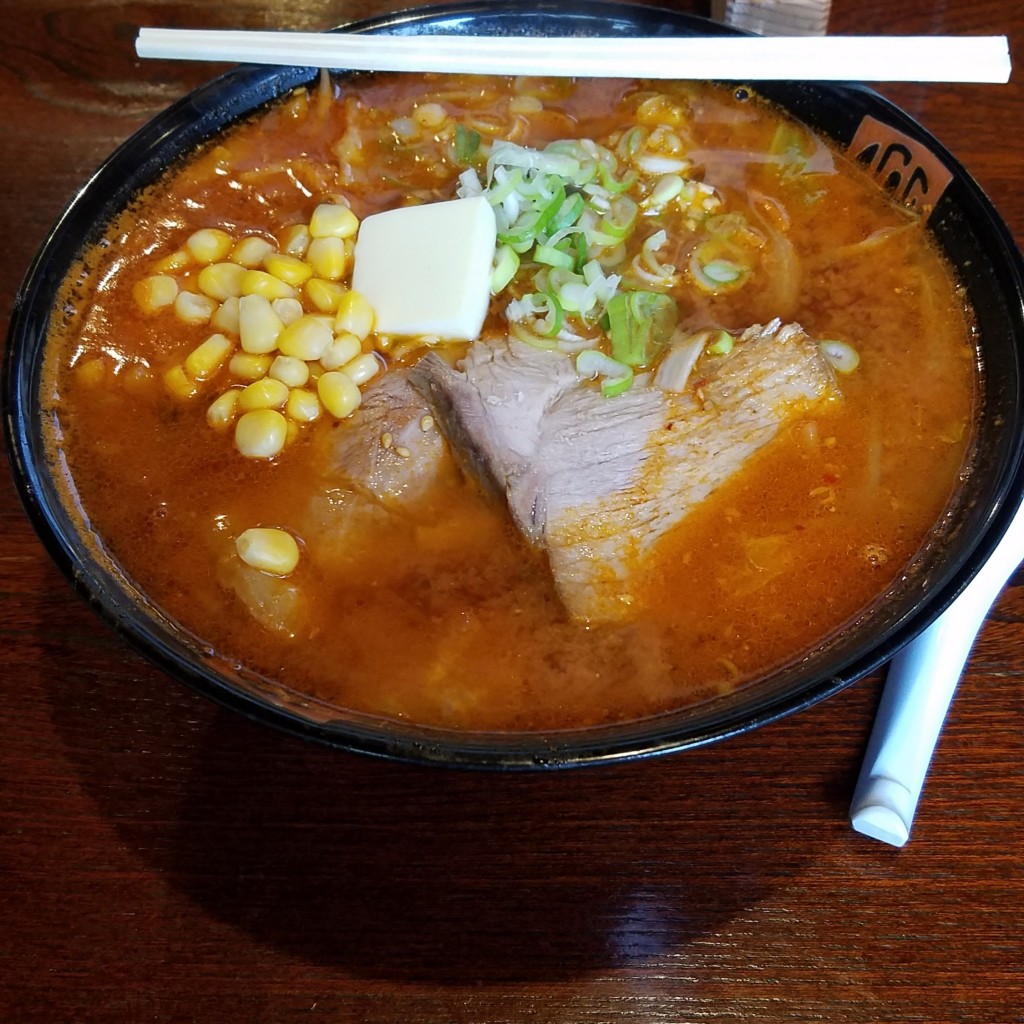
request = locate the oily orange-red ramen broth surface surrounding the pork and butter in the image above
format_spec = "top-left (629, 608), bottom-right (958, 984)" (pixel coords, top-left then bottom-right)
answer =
top-left (44, 76), bottom-right (977, 730)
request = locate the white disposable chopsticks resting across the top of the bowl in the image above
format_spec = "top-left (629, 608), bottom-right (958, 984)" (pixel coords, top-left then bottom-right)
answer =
top-left (135, 29), bottom-right (1011, 83)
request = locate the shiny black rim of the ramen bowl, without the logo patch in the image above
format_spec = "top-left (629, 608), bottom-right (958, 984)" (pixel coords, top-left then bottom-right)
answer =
top-left (2, 0), bottom-right (1024, 769)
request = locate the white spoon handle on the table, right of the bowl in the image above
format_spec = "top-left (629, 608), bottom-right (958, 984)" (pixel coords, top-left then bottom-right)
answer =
top-left (850, 506), bottom-right (1024, 846)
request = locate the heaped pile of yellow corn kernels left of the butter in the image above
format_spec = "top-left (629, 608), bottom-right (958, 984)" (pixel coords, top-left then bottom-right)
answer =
top-left (133, 203), bottom-right (384, 459)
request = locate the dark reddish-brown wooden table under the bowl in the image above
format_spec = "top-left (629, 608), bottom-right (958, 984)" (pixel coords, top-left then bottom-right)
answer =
top-left (0, 0), bottom-right (1024, 1024)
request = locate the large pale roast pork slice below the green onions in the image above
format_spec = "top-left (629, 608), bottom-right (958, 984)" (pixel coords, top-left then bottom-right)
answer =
top-left (411, 321), bottom-right (839, 623)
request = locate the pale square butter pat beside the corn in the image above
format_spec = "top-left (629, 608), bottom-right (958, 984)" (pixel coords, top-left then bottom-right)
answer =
top-left (352, 197), bottom-right (497, 341)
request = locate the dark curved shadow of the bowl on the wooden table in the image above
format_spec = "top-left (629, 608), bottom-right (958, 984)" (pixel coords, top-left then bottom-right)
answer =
top-left (37, 618), bottom-right (850, 983)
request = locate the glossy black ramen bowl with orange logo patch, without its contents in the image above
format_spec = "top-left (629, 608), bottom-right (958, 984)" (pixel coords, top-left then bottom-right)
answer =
top-left (3, 0), bottom-right (1024, 768)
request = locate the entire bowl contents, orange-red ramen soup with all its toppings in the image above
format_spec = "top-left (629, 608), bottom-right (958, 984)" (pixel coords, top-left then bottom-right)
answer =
top-left (44, 76), bottom-right (977, 730)
